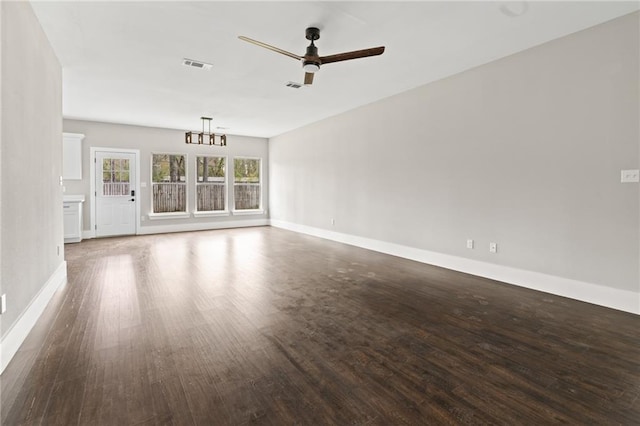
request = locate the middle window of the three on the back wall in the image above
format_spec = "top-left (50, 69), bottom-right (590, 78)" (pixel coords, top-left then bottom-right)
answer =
top-left (196, 156), bottom-right (227, 212)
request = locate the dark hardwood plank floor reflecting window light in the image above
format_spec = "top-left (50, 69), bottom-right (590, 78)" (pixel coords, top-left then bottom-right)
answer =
top-left (2, 227), bottom-right (640, 425)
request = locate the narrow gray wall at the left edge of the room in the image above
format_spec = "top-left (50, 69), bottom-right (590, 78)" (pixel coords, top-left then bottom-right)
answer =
top-left (0, 2), bottom-right (64, 335)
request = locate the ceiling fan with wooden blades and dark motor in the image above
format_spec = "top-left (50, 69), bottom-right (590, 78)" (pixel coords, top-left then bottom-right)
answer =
top-left (238, 27), bottom-right (384, 85)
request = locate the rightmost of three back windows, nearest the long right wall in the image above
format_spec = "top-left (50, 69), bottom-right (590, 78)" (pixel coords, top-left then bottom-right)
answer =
top-left (233, 158), bottom-right (262, 210)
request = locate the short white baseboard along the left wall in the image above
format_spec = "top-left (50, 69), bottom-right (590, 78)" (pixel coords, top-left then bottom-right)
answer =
top-left (0, 261), bottom-right (67, 373)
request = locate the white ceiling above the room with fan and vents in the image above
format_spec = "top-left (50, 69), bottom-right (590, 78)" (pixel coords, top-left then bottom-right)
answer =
top-left (32, 1), bottom-right (639, 137)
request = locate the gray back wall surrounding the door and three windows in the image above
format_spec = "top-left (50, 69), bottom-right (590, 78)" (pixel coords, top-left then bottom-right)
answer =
top-left (64, 117), bottom-right (269, 232)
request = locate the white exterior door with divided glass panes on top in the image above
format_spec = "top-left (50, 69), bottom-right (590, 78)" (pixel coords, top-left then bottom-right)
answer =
top-left (95, 151), bottom-right (138, 237)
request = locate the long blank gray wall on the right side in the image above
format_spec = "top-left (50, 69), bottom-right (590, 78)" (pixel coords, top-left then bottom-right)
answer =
top-left (269, 13), bottom-right (640, 292)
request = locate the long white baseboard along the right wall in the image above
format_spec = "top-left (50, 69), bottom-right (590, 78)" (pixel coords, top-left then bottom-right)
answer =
top-left (270, 219), bottom-right (640, 314)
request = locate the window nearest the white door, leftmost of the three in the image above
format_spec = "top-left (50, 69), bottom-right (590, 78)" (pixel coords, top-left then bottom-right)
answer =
top-left (151, 154), bottom-right (187, 213)
